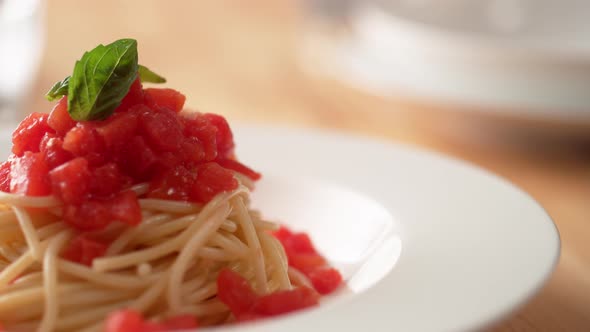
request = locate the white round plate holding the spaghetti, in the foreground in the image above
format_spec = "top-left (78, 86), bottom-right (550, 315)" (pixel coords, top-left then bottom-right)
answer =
top-left (0, 126), bottom-right (559, 332)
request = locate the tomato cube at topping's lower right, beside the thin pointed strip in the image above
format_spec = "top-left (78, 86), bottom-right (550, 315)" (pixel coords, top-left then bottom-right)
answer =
top-left (190, 162), bottom-right (238, 203)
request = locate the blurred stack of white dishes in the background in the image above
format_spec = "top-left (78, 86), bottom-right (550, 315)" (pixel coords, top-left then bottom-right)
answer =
top-left (311, 0), bottom-right (590, 122)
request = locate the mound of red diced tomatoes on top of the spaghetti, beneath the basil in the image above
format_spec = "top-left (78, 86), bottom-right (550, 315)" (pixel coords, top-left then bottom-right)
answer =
top-left (0, 79), bottom-right (260, 231)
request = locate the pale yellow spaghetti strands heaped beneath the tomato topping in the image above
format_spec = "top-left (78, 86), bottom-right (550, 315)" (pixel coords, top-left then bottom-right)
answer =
top-left (0, 177), bottom-right (312, 331)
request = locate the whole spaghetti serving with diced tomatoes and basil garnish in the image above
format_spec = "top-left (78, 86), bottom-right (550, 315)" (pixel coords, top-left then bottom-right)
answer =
top-left (0, 39), bottom-right (342, 332)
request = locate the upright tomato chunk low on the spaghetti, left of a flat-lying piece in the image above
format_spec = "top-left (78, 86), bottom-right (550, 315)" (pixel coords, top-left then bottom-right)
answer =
top-left (217, 269), bottom-right (258, 317)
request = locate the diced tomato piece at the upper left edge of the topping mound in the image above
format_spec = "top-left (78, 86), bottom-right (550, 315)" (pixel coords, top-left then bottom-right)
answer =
top-left (12, 112), bottom-right (53, 157)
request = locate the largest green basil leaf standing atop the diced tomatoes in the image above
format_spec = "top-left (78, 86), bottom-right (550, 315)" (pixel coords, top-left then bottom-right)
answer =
top-left (68, 39), bottom-right (138, 121)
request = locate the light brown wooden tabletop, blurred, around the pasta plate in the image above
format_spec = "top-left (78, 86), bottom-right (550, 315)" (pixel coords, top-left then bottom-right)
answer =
top-left (29, 0), bottom-right (590, 331)
